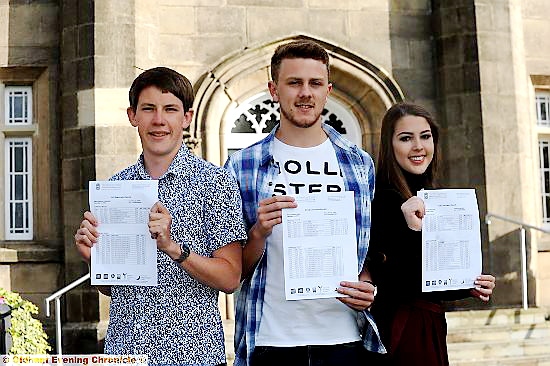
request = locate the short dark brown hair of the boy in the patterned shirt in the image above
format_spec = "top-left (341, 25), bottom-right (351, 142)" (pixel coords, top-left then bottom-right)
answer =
top-left (129, 67), bottom-right (195, 112)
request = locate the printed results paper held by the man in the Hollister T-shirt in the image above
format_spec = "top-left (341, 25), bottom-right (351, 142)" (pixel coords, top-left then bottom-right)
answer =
top-left (283, 191), bottom-right (358, 300)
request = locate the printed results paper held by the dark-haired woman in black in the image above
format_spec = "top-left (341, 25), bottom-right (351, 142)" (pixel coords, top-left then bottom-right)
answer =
top-left (417, 189), bottom-right (482, 292)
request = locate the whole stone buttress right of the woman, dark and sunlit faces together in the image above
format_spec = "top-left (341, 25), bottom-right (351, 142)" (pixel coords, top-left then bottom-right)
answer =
top-left (433, 0), bottom-right (538, 305)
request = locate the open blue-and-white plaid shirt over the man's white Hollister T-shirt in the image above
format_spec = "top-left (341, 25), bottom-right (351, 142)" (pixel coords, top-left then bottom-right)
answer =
top-left (225, 124), bottom-right (386, 366)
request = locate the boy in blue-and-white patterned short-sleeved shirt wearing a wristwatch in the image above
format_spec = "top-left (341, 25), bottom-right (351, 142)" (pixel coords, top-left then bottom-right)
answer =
top-left (75, 67), bottom-right (246, 366)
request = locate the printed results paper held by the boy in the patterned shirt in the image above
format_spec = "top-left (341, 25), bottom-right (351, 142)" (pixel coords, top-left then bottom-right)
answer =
top-left (89, 180), bottom-right (158, 286)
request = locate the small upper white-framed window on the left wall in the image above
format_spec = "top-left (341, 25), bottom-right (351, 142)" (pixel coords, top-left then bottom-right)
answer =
top-left (4, 86), bottom-right (32, 126)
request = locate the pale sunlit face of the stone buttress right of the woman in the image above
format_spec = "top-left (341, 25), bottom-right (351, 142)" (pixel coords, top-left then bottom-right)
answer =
top-left (474, 0), bottom-right (540, 304)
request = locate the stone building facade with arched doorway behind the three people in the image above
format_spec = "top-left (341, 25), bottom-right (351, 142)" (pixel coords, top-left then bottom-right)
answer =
top-left (0, 0), bottom-right (550, 353)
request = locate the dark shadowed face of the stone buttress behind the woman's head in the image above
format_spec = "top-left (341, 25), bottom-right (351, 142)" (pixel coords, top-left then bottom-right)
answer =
top-left (432, 0), bottom-right (490, 306)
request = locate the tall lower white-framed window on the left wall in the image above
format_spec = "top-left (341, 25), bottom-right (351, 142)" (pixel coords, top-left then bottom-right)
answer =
top-left (5, 137), bottom-right (33, 240)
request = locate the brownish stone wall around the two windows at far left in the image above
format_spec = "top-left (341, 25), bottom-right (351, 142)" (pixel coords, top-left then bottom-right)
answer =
top-left (0, 1), bottom-right (63, 350)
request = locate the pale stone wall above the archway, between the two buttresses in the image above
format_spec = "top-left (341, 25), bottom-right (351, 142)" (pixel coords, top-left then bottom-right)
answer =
top-left (135, 0), bottom-right (392, 86)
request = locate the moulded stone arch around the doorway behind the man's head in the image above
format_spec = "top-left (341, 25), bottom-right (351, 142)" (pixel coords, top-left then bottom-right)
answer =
top-left (194, 36), bottom-right (403, 165)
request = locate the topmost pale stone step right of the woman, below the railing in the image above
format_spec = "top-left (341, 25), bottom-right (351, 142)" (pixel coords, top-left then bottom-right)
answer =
top-left (445, 308), bottom-right (549, 330)
